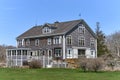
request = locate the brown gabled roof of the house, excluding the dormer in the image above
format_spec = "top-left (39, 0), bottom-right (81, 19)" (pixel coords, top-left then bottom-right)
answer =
top-left (17, 19), bottom-right (95, 39)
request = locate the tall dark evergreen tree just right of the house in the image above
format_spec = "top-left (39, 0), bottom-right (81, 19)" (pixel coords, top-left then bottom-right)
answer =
top-left (95, 22), bottom-right (108, 57)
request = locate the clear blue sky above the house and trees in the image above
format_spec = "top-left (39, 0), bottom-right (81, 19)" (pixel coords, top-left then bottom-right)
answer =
top-left (0, 0), bottom-right (120, 46)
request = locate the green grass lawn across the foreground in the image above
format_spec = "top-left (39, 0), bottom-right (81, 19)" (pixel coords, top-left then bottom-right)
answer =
top-left (0, 68), bottom-right (120, 80)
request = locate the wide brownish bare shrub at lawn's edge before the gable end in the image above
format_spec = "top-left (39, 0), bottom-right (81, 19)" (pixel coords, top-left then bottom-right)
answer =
top-left (80, 58), bottom-right (103, 72)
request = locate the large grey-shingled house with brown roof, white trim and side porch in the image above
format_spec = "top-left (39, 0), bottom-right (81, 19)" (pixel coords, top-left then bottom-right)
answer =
top-left (6, 19), bottom-right (97, 67)
